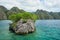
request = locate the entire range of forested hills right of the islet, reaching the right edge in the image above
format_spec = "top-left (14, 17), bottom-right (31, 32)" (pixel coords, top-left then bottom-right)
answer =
top-left (35, 9), bottom-right (60, 19)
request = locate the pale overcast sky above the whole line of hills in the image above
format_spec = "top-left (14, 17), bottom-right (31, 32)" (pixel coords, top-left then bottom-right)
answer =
top-left (0, 0), bottom-right (60, 12)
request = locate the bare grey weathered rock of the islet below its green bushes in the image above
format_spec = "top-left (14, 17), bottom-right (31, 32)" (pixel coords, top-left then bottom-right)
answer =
top-left (10, 19), bottom-right (35, 34)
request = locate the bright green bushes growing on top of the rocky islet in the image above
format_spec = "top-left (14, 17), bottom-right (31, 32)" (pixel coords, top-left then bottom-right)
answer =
top-left (9, 12), bottom-right (38, 22)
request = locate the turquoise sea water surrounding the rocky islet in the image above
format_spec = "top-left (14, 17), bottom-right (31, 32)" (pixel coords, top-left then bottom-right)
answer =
top-left (0, 20), bottom-right (60, 40)
